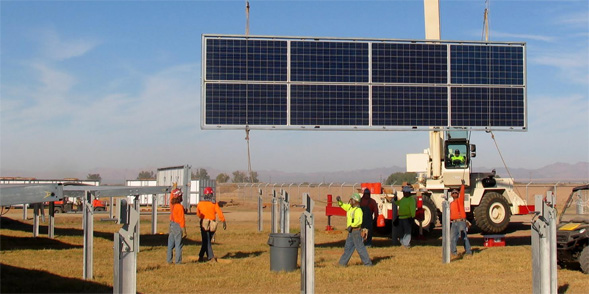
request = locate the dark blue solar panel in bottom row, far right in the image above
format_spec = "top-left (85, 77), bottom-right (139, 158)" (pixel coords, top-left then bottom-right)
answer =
top-left (451, 87), bottom-right (525, 127)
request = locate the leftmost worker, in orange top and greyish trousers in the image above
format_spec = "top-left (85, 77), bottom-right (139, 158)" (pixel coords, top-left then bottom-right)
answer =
top-left (167, 189), bottom-right (186, 264)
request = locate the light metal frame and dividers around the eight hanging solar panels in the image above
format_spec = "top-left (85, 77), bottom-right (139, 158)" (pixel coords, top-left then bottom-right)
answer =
top-left (201, 34), bottom-right (528, 131)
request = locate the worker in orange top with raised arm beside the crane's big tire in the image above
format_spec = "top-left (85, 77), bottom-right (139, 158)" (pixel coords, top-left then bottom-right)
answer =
top-left (450, 180), bottom-right (472, 256)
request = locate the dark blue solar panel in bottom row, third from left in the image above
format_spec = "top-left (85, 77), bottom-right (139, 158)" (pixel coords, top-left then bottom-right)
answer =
top-left (372, 86), bottom-right (448, 126)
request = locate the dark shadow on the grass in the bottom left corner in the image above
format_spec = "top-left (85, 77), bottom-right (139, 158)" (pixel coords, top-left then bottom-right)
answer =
top-left (0, 262), bottom-right (113, 293)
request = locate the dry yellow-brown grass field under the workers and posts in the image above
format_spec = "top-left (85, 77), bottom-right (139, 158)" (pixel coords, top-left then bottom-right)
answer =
top-left (0, 183), bottom-right (589, 293)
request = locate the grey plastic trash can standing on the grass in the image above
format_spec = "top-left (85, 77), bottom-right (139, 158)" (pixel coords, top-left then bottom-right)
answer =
top-left (268, 233), bottom-right (301, 272)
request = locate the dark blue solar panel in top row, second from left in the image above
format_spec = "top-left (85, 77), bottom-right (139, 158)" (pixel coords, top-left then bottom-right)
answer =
top-left (291, 41), bottom-right (368, 83)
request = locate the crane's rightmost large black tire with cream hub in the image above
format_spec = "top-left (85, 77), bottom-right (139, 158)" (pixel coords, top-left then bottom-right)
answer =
top-left (474, 192), bottom-right (511, 234)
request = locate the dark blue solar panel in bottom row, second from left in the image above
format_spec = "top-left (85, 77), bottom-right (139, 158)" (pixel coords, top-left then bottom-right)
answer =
top-left (291, 85), bottom-right (368, 126)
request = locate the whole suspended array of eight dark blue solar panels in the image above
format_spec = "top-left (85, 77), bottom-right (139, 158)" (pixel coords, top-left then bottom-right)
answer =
top-left (201, 35), bottom-right (527, 130)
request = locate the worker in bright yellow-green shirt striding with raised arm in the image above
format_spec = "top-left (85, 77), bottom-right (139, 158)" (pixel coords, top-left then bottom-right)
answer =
top-left (336, 193), bottom-right (372, 266)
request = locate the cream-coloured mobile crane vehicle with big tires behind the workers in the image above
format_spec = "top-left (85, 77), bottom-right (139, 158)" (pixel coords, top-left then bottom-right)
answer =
top-left (326, 131), bottom-right (534, 234)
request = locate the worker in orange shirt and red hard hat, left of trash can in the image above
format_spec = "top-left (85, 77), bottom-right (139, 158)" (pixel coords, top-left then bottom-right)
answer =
top-left (196, 187), bottom-right (227, 262)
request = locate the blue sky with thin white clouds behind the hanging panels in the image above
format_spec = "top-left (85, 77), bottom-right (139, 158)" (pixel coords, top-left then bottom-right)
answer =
top-left (0, 0), bottom-right (589, 180)
